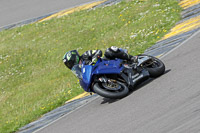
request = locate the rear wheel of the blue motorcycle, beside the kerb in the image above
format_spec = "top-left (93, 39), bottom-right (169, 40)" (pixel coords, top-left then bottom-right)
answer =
top-left (140, 55), bottom-right (165, 78)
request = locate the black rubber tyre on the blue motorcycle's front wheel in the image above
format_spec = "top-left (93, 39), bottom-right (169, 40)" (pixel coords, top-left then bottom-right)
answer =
top-left (93, 81), bottom-right (129, 99)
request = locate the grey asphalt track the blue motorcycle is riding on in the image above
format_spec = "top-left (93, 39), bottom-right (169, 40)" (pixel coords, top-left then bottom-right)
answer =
top-left (37, 31), bottom-right (200, 133)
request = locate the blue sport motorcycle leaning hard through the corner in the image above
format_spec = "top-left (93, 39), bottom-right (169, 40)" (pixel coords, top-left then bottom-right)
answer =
top-left (74, 55), bottom-right (165, 99)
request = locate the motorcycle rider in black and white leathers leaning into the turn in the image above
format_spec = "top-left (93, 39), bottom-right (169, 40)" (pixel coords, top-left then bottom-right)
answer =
top-left (63, 46), bottom-right (137, 78)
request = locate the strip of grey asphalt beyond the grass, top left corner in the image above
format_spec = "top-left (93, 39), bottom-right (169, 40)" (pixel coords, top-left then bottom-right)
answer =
top-left (0, 0), bottom-right (95, 28)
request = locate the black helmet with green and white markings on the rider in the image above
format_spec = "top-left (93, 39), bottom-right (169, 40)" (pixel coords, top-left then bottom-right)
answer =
top-left (63, 50), bottom-right (80, 69)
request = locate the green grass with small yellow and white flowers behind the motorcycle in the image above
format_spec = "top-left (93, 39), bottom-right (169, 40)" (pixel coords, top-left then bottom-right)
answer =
top-left (0, 0), bottom-right (181, 133)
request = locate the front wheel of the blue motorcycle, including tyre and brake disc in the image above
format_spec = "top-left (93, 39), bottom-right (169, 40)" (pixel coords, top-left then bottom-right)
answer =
top-left (93, 81), bottom-right (129, 99)
